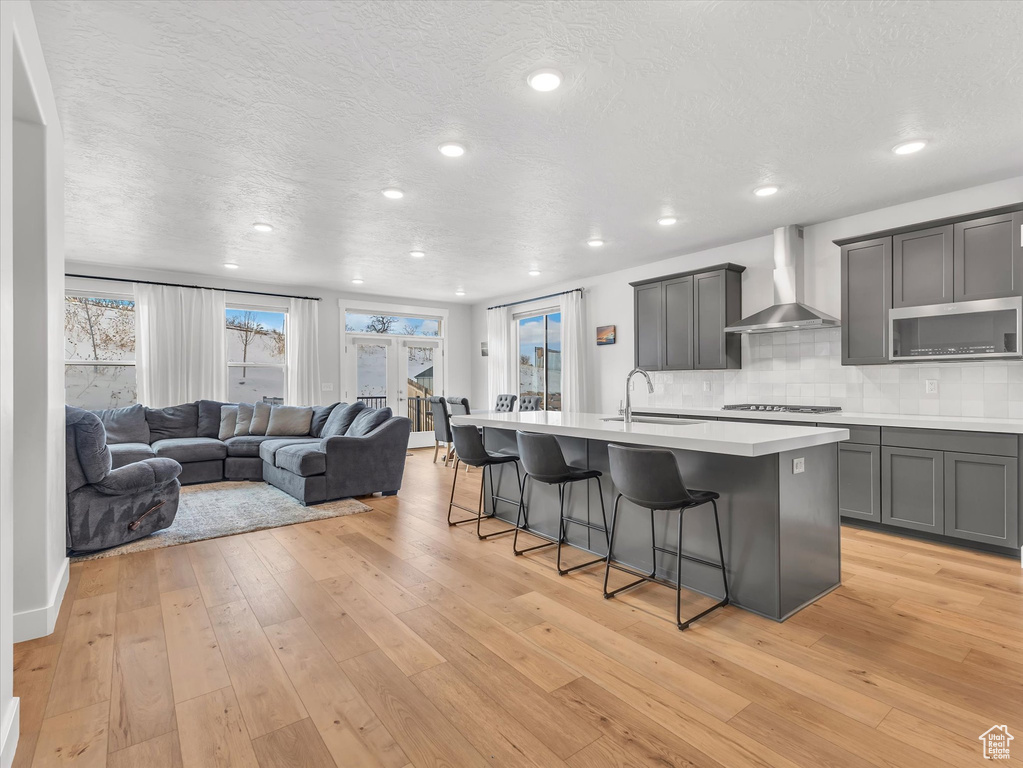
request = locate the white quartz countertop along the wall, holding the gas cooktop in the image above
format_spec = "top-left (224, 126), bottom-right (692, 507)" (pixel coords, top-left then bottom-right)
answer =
top-left (635, 405), bottom-right (1023, 435)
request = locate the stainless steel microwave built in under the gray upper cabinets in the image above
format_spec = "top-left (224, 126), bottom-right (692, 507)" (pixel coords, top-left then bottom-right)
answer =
top-left (888, 297), bottom-right (1023, 362)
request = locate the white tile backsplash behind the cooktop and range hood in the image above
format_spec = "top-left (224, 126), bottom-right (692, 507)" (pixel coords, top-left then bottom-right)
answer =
top-left (646, 328), bottom-right (1023, 418)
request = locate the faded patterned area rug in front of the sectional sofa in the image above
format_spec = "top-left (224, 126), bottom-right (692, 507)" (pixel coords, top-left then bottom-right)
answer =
top-left (72, 482), bottom-right (370, 561)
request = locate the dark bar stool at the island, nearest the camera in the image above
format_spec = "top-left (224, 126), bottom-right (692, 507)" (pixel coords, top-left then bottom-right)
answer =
top-left (604, 445), bottom-right (728, 630)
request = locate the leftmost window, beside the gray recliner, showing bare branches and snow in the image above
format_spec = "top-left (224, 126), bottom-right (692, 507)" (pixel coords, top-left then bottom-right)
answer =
top-left (64, 296), bottom-right (138, 409)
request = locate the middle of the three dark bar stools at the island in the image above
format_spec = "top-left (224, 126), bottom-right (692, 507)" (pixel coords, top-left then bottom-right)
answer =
top-left (512, 432), bottom-right (611, 576)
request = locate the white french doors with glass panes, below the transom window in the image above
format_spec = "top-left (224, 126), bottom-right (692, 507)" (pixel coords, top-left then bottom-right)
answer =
top-left (345, 333), bottom-right (444, 448)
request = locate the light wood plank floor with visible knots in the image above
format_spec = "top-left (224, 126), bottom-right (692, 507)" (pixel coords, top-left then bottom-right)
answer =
top-left (14, 451), bottom-right (1023, 768)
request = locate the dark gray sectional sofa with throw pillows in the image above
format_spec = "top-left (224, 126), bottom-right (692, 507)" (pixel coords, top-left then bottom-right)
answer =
top-left (94, 400), bottom-right (411, 504)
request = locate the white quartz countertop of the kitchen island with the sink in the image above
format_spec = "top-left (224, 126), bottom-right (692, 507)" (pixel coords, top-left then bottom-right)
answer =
top-left (451, 411), bottom-right (849, 456)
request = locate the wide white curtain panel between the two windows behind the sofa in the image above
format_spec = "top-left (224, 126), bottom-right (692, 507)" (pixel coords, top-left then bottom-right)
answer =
top-left (134, 283), bottom-right (227, 408)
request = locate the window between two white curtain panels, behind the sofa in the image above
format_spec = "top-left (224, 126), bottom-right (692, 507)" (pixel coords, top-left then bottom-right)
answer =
top-left (226, 307), bottom-right (287, 405)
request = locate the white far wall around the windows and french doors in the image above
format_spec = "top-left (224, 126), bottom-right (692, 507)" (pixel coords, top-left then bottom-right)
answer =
top-left (66, 262), bottom-right (472, 403)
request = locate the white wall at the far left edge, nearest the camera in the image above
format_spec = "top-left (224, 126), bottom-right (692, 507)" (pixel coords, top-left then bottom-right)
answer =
top-left (0, 0), bottom-right (68, 767)
